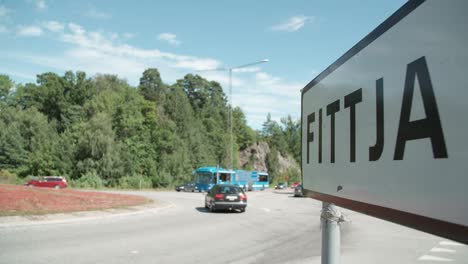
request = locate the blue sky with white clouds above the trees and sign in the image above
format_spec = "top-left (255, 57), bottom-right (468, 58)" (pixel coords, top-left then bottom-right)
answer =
top-left (0, 0), bottom-right (405, 129)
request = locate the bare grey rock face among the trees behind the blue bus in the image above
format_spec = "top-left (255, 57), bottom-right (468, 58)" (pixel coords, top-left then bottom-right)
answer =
top-left (239, 142), bottom-right (300, 173)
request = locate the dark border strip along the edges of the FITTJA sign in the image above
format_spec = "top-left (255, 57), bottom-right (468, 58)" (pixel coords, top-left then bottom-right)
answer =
top-left (301, 0), bottom-right (468, 245)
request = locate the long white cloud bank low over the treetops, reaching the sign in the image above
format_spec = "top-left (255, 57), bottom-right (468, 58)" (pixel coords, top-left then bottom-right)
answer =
top-left (8, 22), bottom-right (304, 129)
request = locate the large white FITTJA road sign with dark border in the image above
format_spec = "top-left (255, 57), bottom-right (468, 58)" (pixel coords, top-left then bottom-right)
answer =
top-left (302, 0), bottom-right (468, 244)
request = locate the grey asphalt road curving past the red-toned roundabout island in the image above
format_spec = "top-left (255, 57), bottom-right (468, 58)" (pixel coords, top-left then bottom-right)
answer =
top-left (0, 191), bottom-right (468, 264)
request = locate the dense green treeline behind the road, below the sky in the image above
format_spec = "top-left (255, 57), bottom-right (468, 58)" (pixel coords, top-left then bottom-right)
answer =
top-left (0, 69), bottom-right (300, 188)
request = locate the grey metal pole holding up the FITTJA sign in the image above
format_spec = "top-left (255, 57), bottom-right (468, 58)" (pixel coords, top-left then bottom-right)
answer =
top-left (320, 202), bottom-right (341, 264)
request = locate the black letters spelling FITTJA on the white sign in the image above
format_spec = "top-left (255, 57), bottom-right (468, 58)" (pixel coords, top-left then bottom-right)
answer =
top-left (306, 57), bottom-right (448, 164)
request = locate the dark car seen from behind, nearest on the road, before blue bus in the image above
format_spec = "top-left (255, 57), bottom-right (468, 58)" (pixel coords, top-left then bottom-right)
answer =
top-left (205, 184), bottom-right (247, 213)
